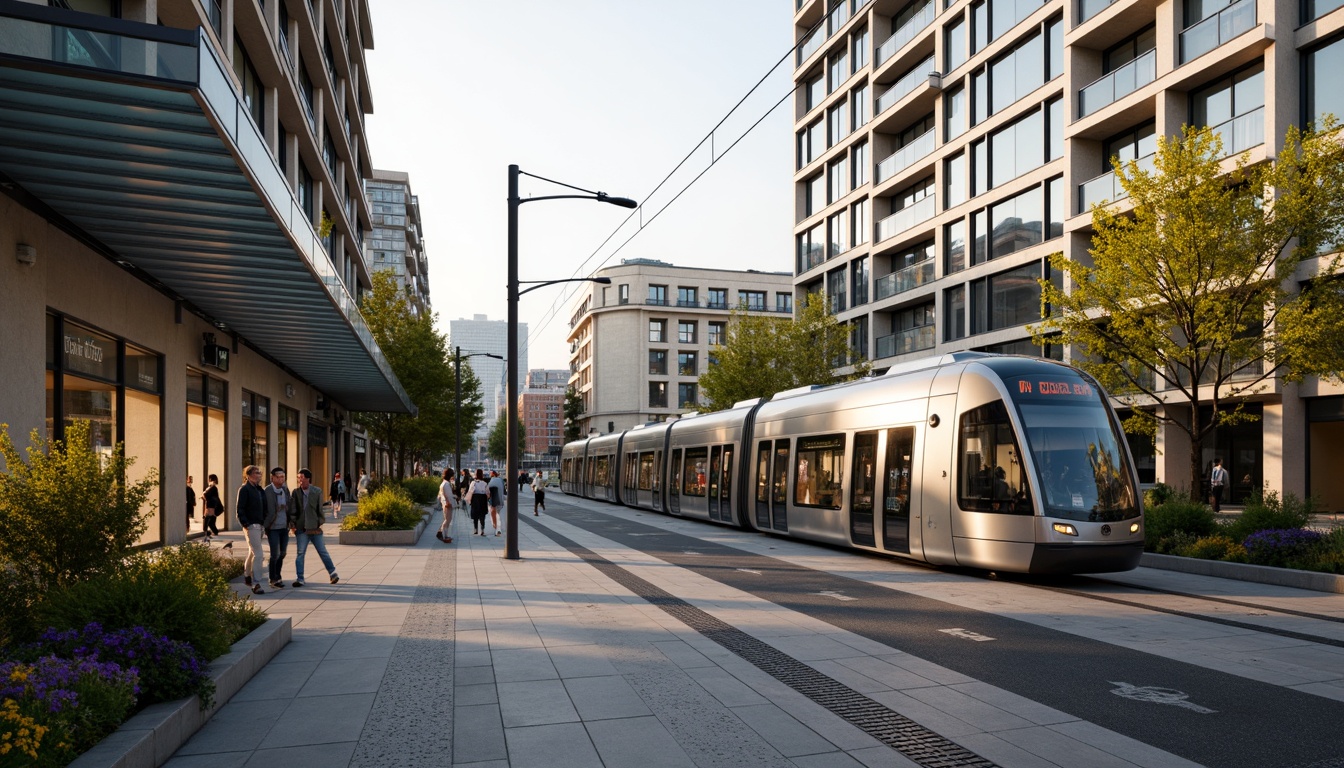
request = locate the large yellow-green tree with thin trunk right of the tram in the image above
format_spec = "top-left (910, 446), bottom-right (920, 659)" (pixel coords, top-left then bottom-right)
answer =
top-left (1031, 118), bottom-right (1344, 486)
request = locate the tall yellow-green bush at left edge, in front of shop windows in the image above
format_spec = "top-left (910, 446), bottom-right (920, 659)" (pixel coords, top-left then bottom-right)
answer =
top-left (0, 421), bottom-right (157, 643)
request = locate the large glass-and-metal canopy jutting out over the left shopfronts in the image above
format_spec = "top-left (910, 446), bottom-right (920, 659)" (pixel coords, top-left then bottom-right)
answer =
top-left (0, 0), bottom-right (414, 412)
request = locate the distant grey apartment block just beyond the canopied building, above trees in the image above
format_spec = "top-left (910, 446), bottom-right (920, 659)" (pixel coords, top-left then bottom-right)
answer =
top-left (364, 168), bottom-right (430, 313)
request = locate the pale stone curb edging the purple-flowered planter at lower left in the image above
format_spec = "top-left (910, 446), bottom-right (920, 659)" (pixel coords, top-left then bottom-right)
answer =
top-left (70, 619), bottom-right (293, 768)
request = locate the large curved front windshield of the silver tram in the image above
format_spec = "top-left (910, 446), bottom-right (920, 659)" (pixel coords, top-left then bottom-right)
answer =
top-left (1005, 370), bottom-right (1138, 522)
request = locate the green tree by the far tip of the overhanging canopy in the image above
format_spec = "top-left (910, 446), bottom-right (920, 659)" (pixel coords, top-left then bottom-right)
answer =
top-left (355, 272), bottom-right (484, 477)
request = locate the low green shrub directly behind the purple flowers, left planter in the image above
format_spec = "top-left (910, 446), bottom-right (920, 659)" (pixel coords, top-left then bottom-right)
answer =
top-left (35, 543), bottom-right (265, 659)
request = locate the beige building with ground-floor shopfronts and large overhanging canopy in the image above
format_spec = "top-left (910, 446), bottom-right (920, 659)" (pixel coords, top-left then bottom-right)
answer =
top-left (0, 0), bottom-right (413, 543)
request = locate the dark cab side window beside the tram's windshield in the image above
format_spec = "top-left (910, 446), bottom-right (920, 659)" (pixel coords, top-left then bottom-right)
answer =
top-left (957, 401), bottom-right (1032, 515)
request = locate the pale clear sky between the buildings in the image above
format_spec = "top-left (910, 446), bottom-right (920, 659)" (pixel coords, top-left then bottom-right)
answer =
top-left (367, 0), bottom-right (793, 369)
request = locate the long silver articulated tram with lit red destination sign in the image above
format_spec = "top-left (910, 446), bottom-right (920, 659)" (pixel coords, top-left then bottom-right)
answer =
top-left (560, 352), bottom-right (1144, 573)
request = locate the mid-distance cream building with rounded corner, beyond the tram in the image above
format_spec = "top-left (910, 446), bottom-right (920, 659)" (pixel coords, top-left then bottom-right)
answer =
top-left (569, 258), bottom-right (793, 433)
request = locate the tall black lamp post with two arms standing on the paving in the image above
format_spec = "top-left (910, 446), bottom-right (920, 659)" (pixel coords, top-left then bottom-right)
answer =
top-left (504, 165), bottom-right (640, 560)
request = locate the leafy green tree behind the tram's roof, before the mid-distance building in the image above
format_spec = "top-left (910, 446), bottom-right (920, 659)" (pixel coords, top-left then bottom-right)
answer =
top-left (700, 293), bottom-right (872, 412)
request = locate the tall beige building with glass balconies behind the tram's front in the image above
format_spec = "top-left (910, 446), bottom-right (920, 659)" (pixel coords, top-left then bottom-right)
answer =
top-left (794, 0), bottom-right (1344, 510)
